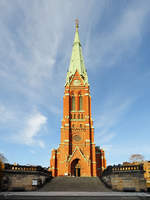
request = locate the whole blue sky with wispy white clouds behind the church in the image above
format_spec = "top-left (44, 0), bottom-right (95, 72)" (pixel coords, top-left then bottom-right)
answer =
top-left (0, 0), bottom-right (150, 166)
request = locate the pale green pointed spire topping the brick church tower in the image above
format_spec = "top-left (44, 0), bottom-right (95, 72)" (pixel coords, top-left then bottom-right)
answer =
top-left (66, 20), bottom-right (88, 84)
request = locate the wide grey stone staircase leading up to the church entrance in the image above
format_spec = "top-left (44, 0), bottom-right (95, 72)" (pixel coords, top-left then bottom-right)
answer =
top-left (39, 177), bottom-right (111, 192)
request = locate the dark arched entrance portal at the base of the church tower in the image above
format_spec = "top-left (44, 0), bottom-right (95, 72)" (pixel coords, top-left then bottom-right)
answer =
top-left (71, 159), bottom-right (81, 176)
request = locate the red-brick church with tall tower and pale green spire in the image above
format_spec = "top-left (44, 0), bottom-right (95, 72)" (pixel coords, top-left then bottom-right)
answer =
top-left (50, 20), bottom-right (106, 177)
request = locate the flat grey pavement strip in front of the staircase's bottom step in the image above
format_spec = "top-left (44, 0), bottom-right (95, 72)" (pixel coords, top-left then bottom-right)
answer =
top-left (0, 191), bottom-right (150, 200)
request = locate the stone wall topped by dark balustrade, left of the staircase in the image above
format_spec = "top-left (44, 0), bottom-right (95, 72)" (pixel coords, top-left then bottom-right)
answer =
top-left (2, 164), bottom-right (52, 191)
